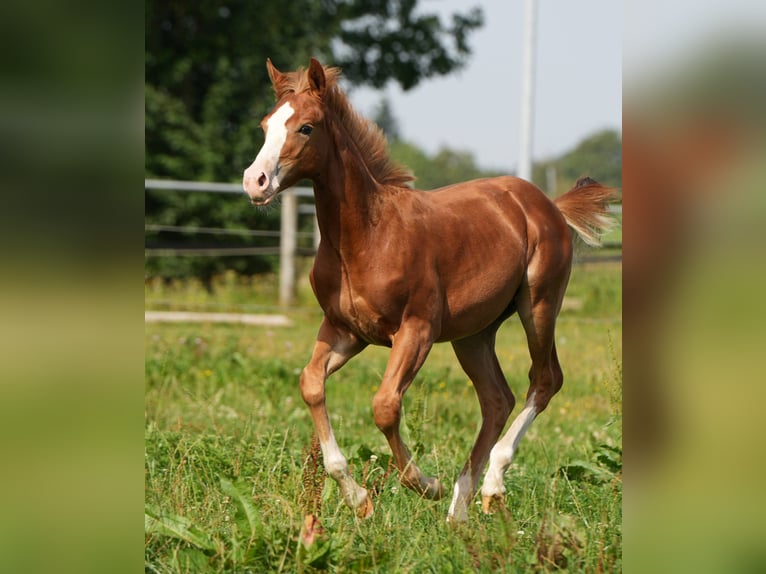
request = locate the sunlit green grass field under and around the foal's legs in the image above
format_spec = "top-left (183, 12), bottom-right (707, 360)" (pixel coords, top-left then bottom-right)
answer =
top-left (145, 263), bottom-right (622, 573)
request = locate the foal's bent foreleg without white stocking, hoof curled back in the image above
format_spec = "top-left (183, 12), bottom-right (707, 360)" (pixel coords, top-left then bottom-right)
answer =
top-left (372, 325), bottom-right (444, 500)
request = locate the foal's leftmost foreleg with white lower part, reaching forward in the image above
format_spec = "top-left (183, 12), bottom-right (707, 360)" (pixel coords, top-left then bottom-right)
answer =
top-left (300, 319), bottom-right (373, 518)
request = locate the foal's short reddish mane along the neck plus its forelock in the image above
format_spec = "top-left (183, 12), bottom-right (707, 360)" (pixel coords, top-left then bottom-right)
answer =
top-left (274, 66), bottom-right (415, 187)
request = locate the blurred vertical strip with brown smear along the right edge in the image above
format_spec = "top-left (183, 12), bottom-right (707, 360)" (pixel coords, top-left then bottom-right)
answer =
top-left (623, 1), bottom-right (766, 572)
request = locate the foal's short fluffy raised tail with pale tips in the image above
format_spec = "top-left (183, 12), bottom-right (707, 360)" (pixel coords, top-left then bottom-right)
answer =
top-left (553, 177), bottom-right (617, 247)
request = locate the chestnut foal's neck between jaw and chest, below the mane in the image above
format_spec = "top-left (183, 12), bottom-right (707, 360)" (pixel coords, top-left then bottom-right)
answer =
top-left (314, 124), bottom-right (385, 253)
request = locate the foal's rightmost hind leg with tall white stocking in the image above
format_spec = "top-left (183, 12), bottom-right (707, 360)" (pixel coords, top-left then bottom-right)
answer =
top-left (481, 276), bottom-right (568, 513)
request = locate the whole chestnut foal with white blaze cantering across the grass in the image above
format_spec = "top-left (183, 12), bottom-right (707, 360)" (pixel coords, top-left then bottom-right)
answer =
top-left (243, 59), bottom-right (613, 521)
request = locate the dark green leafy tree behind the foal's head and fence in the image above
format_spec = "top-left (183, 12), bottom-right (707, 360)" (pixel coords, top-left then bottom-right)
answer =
top-left (145, 0), bottom-right (483, 284)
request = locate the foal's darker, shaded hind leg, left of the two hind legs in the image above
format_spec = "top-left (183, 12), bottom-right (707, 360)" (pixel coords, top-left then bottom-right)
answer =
top-left (447, 323), bottom-right (515, 522)
